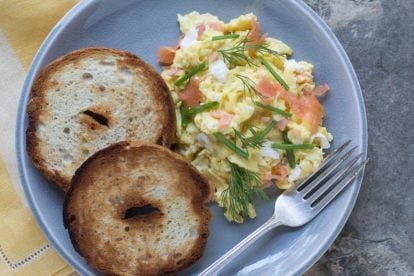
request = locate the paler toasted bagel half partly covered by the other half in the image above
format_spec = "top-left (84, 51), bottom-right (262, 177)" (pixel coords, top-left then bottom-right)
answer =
top-left (26, 48), bottom-right (176, 191)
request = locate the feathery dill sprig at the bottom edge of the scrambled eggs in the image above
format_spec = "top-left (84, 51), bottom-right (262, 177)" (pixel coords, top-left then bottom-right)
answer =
top-left (221, 161), bottom-right (267, 221)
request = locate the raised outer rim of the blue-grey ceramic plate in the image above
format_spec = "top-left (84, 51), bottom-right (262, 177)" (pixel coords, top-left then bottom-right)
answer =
top-left (15, 0), bottom-right (368, 275)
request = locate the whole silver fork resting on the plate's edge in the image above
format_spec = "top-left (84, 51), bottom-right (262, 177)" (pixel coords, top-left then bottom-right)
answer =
top-left (199, 140), bottom-right (368, 276)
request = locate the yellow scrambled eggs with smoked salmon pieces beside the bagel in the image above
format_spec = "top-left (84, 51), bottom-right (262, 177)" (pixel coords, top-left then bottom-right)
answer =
top-left (162, 12), bottom-right (332, 222)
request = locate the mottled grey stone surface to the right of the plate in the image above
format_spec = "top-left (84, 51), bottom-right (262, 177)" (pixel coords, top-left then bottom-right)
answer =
top-left (305, 0), bottom-right (414, 276)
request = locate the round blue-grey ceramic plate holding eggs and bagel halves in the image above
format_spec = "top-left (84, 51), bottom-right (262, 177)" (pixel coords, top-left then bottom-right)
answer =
top-left (16, 0), bottom-right (367, 275)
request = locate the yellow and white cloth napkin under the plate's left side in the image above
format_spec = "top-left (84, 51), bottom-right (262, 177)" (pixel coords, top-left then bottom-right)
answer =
top-left (0, 0), bottom-right (77, 275)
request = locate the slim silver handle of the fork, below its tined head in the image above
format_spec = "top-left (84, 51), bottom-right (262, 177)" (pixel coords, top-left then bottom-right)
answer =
top-left (199, 216), bottom-right (282, 276)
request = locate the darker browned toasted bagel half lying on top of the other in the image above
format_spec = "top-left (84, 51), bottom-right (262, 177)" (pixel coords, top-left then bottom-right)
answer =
top-left (63, 142), bottom-right (211, 275)
